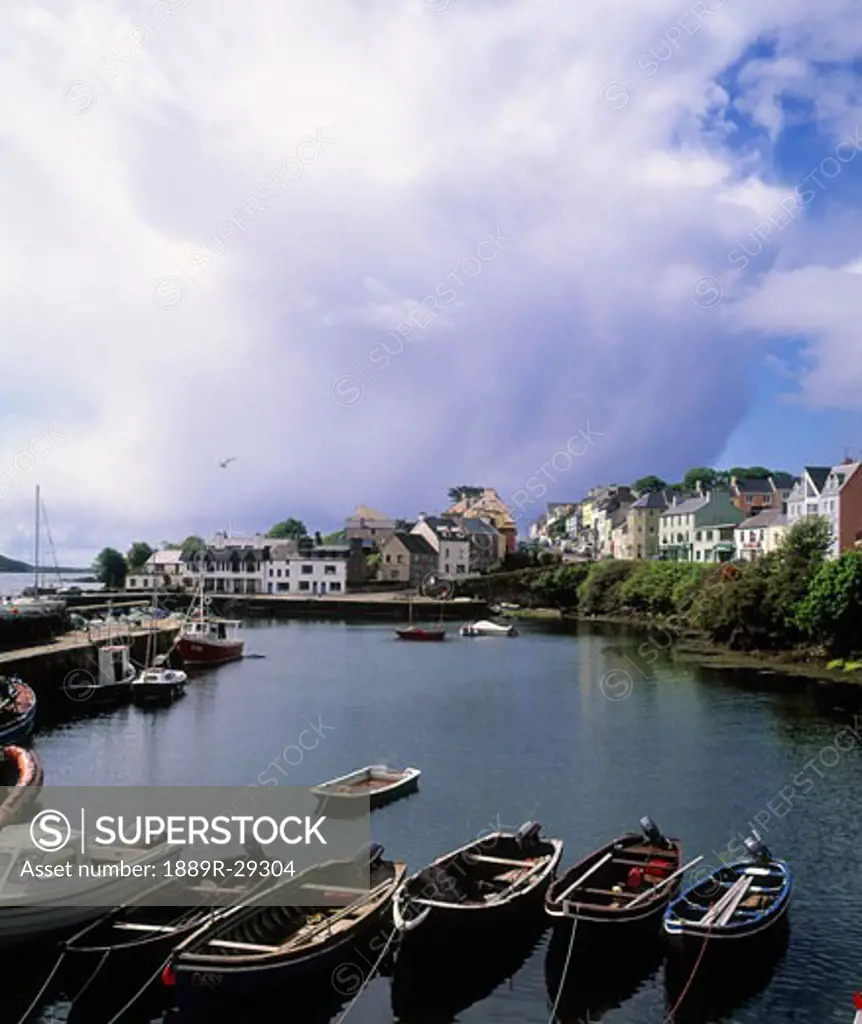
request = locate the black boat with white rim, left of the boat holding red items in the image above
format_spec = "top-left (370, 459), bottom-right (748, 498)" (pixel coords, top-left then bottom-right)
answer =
top-left (393, 821), bottom-right (563, 948)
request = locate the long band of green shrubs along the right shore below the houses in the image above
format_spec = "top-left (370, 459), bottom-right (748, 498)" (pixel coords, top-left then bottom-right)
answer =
top-left (460, 518), bottom-right (862, 681)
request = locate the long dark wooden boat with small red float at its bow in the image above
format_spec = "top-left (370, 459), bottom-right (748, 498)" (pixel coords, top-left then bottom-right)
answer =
top-left (169, 844), bottom-right (406, 1016)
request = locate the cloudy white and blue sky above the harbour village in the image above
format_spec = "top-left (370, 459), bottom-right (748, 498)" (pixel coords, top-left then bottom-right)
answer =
top-left (0, 0), bottom-right (862, 561)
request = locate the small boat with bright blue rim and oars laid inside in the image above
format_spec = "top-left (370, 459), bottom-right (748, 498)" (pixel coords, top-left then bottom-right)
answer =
top-left (664, 833), bottom-right (793, 957)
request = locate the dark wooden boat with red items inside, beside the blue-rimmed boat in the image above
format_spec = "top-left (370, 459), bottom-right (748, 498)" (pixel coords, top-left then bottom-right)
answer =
top-left (545, 817), bottom-right (683, 945)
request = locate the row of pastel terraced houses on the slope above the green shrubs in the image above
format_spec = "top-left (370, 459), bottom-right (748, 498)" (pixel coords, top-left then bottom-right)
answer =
top-left (530, 459), bottom-right (862, 562)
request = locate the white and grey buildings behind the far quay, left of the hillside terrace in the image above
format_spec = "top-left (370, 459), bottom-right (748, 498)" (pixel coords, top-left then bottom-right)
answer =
top-left (126, 488), bottom-right (516, 596)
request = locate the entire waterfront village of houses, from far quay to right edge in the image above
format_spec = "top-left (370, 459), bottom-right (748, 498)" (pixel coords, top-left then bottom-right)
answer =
top-left (119, 458), bottom-right (862, 597)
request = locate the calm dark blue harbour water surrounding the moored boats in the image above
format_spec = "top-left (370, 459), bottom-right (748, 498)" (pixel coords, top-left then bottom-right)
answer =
top-left (6, 622), bottom-right (862, 1024)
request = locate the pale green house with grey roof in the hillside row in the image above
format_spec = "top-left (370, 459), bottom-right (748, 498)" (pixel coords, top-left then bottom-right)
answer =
top-left (658, 490), bottom-right (745, 563)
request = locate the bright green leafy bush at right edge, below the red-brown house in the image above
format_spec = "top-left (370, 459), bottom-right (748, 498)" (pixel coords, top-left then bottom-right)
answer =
top-left (795, 551), bottom-right (862, 656)
